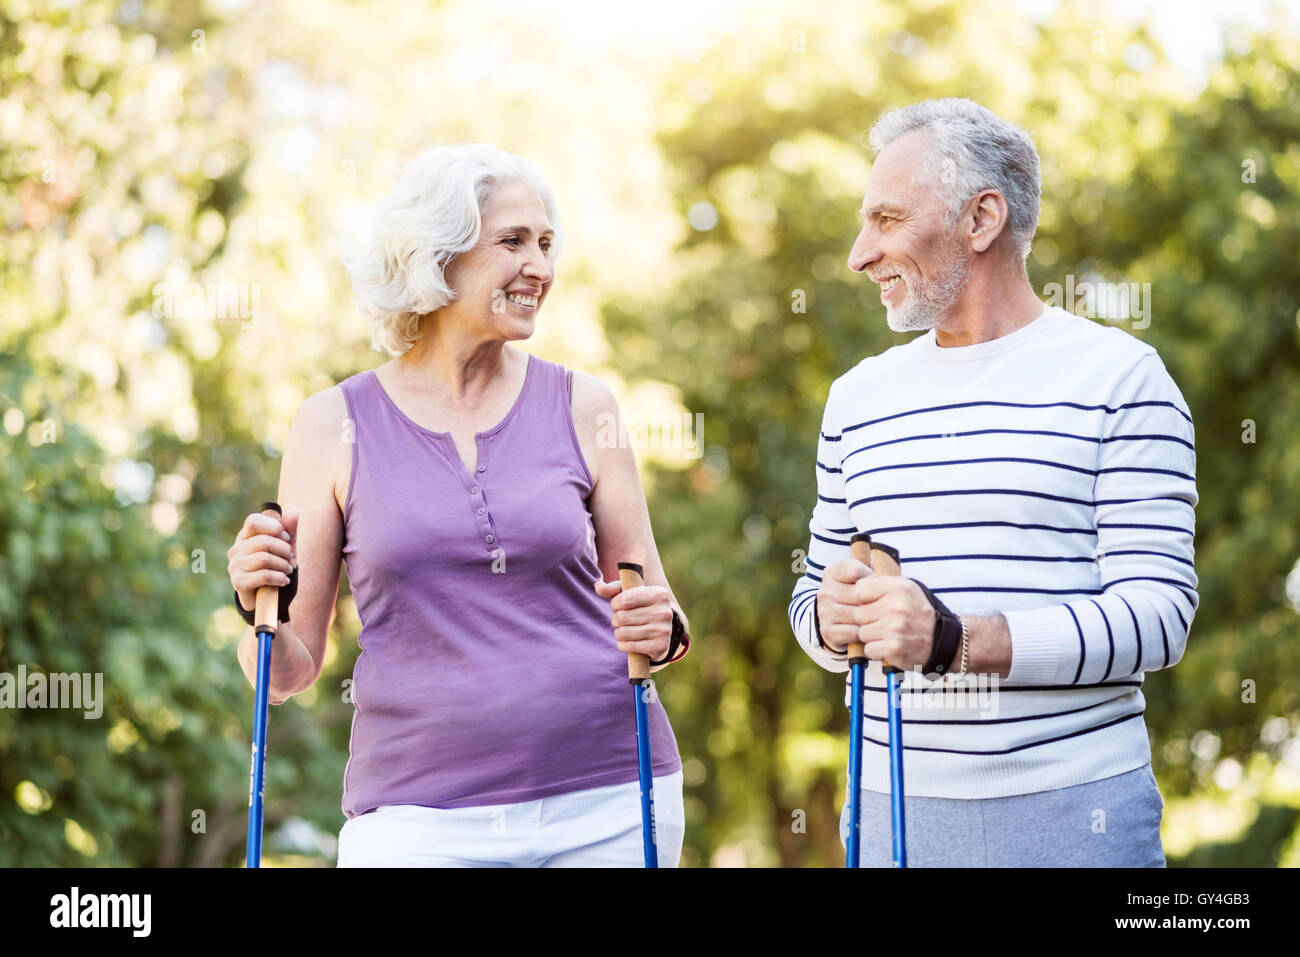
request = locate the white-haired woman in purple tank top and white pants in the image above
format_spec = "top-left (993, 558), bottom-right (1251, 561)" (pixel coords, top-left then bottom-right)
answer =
top-left (230, 144), bottom-right (689, 867)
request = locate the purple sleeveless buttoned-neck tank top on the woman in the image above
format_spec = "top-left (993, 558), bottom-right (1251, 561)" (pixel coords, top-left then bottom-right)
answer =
top-left (341, 356), bottom-right (681, 818)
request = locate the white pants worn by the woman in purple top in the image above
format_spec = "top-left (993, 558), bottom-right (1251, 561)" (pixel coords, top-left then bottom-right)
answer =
top-left (338, 771), bottom-right (686, 867)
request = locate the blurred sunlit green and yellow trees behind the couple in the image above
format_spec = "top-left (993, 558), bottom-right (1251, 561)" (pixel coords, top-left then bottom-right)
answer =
top-left (0, 0), bottom-right (1300, 866)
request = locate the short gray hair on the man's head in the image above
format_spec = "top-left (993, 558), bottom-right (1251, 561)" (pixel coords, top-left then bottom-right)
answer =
top-left (871, 98), bottom-right (1043, 259)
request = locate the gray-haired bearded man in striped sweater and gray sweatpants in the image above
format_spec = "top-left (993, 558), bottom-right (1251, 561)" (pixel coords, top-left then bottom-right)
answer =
top-left (789, 99), bottom-right (1199, 867)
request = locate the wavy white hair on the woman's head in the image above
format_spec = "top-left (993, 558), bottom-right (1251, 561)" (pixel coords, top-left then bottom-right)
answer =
top-left (346, 143), bottom-right (562, 356)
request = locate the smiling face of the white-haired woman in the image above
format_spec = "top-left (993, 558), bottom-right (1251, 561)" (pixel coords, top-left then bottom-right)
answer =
top-left (443, 183), bottom-right (555, 339)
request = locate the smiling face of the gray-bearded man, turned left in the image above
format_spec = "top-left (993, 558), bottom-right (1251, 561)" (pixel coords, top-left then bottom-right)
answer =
top-left (849, 131), bottom-right (974, 332)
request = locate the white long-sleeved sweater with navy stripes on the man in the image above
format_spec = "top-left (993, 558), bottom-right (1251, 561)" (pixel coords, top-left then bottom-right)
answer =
top-left (789, 307), bottom-right (1199, 798)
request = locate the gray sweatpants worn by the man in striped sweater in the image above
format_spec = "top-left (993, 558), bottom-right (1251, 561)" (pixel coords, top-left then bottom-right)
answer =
top-left (840, 765), bottom-right (1165, 867)
